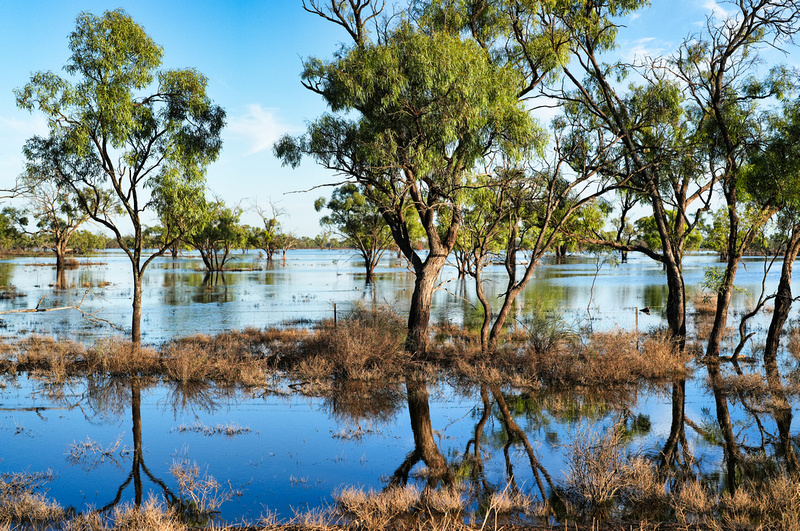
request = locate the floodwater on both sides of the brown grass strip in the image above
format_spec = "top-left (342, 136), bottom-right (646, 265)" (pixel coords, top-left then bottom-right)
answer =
top-left (0, 250), bottom-right (796, 522)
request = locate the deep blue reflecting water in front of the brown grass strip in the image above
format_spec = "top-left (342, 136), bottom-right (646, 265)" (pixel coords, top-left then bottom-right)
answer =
top-left (0, 372), bottom-right (732, 522)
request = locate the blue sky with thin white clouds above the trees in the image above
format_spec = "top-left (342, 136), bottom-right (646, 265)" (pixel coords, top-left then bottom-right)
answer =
top-left (0, 0), bottom-right (796, 236)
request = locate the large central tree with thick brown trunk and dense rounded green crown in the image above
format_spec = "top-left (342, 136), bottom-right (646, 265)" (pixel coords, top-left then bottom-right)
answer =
top-left (275, 0), bottom-right (542, 358)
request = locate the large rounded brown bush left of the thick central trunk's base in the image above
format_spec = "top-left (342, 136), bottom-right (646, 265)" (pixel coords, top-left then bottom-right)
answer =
top-left (298, 307), bottom-right (408, 380)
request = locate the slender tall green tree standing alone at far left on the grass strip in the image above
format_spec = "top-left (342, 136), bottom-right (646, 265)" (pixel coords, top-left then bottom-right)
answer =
top-left (15, 9), bottom-right (225, 346)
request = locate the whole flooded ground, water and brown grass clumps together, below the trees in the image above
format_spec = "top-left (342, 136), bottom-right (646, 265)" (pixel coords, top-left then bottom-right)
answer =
top-left (0, 251), bottom-right (800, 529)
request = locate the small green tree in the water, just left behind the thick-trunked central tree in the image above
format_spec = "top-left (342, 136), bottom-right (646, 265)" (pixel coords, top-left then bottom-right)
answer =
top-left (314, 183), bottom-right (393, 284)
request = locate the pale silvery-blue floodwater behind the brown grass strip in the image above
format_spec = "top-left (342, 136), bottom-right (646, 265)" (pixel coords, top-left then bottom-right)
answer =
top-left (0, 250), bottom-right (779, 344)
